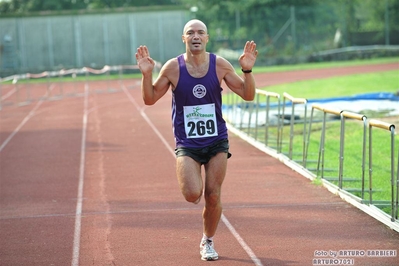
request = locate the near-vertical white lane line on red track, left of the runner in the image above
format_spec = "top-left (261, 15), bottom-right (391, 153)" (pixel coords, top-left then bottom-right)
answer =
top-left (71, 84), bottom-right (89, 266)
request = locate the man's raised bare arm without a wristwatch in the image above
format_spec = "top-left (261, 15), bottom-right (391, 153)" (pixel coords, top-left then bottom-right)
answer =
top-left (136, 46), bottom-right (170, 105)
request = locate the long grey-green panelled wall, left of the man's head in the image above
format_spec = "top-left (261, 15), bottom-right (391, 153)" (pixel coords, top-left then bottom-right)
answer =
top-left (0, 10), bottom-right (189, 77)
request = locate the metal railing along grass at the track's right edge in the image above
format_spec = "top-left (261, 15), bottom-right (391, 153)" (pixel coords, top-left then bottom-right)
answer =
top-left (224, 89), bottom-right (399, 231)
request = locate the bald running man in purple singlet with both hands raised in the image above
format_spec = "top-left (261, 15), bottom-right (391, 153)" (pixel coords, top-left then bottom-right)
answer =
top-left (136, 19), bottom-right (258, 260)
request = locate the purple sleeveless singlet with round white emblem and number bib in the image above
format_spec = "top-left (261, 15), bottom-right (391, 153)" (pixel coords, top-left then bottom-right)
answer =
top-left (172, 54), bottom-right (228, 148)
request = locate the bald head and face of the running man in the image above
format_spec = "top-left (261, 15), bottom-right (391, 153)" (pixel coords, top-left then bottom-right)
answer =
top-left (182, 21), bottom-right (209, 52)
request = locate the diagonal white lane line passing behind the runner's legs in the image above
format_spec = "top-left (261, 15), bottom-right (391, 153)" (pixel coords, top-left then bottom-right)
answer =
top-left (122, 85), bottom-right (263, 266)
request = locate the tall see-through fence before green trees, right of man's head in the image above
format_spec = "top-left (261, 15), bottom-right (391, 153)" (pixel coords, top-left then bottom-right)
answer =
top-left (197, 0), bottom-right (399, 65)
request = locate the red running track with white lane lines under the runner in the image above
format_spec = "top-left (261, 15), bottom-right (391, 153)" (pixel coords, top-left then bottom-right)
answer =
top-left (0, 65), bottom-right (399, 265)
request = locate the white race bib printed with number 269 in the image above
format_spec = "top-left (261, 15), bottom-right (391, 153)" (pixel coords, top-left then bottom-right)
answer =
top-left (183, 104), bottom-right (218, 138)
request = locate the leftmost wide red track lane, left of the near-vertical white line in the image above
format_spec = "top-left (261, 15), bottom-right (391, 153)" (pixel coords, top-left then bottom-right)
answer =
top-left (0, 95), bottom-right (82, 265)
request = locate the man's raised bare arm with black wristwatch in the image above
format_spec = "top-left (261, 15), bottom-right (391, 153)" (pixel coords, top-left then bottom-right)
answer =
top-left (221, 41), bottom-right (258, 101)
